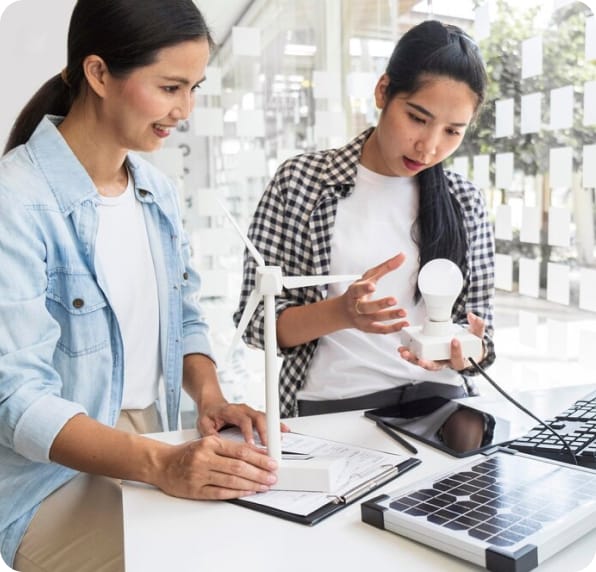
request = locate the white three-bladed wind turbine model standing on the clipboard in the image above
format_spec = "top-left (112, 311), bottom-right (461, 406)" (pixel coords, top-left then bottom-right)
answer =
top-left (220, 202), bottom-right (360, 492)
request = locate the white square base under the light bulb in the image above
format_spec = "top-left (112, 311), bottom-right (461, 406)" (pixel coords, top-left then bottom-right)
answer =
top-left (401, 321), bottom-right (482, 361)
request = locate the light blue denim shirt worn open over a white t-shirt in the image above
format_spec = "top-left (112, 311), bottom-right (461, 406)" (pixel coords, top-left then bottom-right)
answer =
top-left (0, 116), bottom-right (212, 564)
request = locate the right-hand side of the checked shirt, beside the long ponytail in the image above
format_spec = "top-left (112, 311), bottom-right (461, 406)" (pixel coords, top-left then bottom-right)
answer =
top-left (445, 171), bottom-right (495, 375)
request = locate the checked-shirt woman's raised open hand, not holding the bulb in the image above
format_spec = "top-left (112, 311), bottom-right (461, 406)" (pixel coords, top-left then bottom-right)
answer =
top-left (341, 253), bottom-right (409, 334)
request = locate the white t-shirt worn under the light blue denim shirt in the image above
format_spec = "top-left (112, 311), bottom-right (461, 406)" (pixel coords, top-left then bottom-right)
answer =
top-left (95, 173), bottom-right (161, 409)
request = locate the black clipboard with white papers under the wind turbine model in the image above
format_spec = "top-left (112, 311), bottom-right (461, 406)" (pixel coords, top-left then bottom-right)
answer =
top-left (221, 431), bottom-right (421, 526)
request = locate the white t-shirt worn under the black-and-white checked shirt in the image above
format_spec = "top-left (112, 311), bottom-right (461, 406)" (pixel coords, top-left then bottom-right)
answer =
top-left (297, 165), bottom-right (461, 400)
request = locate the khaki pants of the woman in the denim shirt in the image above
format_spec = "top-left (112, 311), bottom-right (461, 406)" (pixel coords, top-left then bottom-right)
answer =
top-left (14, 406), bottom-right (161, 572)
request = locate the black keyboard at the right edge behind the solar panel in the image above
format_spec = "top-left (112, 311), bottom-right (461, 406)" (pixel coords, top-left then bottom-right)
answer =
top-left (507, 391), bottom-right (596, 469)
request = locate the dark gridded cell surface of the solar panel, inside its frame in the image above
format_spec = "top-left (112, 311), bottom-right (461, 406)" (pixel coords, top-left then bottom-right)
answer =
top-left (389, 454), bottom-right (596, 547)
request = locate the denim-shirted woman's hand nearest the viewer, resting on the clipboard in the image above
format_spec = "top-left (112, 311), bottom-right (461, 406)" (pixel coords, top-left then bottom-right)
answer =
top-left (154, 435), bottom-right (277, 500)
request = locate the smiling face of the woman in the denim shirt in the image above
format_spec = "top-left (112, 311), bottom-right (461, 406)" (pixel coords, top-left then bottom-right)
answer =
top-left (102, 39), bottom-right (209, 151)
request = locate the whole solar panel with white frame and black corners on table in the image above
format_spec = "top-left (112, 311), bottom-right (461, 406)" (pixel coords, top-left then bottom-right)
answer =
top-left (361, 450), bottom-right (596, 572)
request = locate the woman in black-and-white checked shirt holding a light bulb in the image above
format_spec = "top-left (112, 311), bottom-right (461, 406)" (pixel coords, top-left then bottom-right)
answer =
top-left (234, 21), bottom-right (495, 422)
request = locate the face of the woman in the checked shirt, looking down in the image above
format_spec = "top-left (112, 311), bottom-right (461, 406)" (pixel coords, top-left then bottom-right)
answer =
top-left (361, 75), bottom-right (478, 177)
